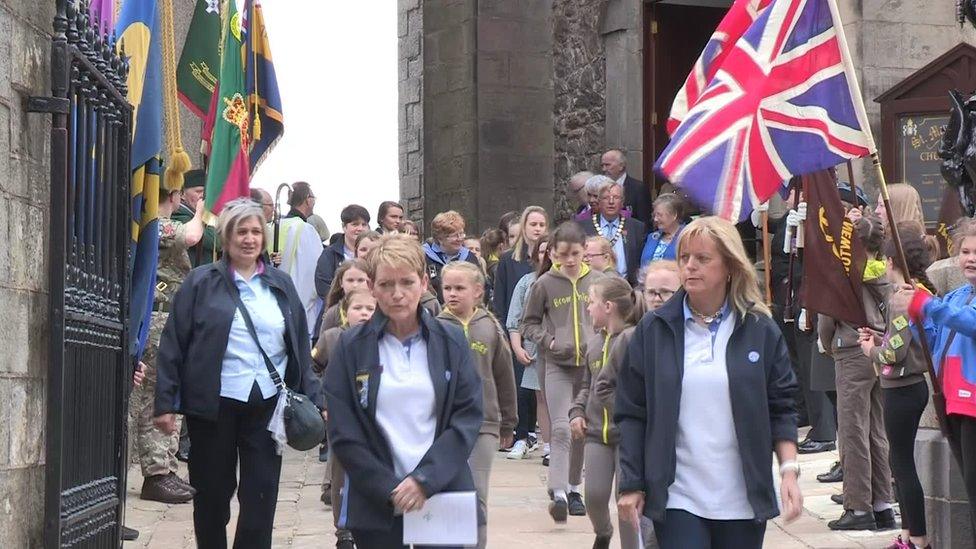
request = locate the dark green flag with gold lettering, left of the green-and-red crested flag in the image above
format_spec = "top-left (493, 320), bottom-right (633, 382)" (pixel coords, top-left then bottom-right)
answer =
top-left (176, 0), bottom-right (220, 118)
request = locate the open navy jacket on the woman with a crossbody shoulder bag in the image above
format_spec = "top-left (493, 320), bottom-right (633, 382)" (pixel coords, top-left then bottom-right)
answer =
top-left (153, 258), bottom-right (322, 421)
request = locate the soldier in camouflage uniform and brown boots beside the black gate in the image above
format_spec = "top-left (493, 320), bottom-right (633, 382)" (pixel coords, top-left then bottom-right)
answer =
top-left (129, 185), bottom-right (203, 503)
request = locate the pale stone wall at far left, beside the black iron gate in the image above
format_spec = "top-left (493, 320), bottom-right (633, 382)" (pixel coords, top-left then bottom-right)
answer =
top-left (0, 0), bottom-right (54, 547)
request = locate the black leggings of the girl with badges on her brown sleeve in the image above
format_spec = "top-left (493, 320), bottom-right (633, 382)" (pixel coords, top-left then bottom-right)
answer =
top-left (881, 381), bottom-right (929, 536)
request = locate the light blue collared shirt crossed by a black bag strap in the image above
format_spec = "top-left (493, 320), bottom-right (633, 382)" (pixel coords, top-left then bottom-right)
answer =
top-left (220, 267), bottom-right (288, 402)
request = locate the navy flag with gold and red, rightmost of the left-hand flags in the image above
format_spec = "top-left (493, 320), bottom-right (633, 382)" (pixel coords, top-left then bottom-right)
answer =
top-left (244, 0), bottom-right (285, 171)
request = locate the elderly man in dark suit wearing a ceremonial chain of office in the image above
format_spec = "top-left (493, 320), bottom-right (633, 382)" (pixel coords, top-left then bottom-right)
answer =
top-left (579, 176), bottom-right (647, 285)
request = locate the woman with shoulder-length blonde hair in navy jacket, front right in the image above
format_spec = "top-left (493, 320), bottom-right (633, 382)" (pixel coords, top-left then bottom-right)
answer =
top-left (614, 217), bottom-right (803, 549)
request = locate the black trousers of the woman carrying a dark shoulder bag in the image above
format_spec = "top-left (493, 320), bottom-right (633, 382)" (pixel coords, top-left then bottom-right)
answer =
top-left (187, 383), bottom-right (281, 549)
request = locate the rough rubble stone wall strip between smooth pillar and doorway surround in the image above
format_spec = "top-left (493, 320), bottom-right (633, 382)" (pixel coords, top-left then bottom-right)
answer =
top-left (552, 0), bottom-right (607, 223)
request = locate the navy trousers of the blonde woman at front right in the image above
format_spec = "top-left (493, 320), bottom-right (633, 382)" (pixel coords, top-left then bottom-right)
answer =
top-left (654, 509), bottom-right (766, 549)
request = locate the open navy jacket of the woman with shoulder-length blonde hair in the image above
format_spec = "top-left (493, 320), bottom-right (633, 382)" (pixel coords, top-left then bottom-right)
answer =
top-left (613, 290), bottom-right (797, 521)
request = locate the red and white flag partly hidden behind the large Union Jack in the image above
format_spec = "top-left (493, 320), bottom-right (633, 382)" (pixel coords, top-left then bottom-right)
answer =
top-left (667, 0), bottom-right (773, 135)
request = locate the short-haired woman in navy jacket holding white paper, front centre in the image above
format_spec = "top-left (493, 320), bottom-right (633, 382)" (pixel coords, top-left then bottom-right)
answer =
top-left (323, 234), bottom-right (484, 549)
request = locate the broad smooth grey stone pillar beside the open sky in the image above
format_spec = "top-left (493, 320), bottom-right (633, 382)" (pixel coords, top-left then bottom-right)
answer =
top-left (410, 0), bottom-right (554, 233)
